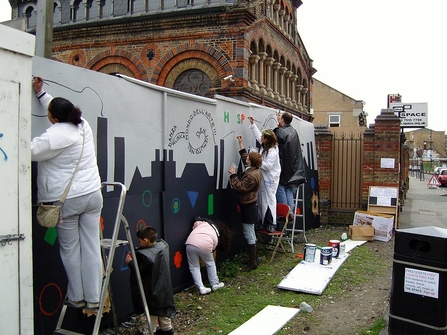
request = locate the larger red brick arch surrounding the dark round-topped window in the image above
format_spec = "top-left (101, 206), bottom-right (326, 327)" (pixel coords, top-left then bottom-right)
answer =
top-left (154, 43), bottom-right (233, 86)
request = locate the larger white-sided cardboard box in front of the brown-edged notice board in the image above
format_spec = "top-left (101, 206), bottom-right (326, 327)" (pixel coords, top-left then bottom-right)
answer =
top-left (352, 211), bottom-right (394, 242)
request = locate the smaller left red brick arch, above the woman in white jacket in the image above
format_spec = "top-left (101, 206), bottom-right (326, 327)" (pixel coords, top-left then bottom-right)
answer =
top-left (86, 50), bottom-right (147, 81)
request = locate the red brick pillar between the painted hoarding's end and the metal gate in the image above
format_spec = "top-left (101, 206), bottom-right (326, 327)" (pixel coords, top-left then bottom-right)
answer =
top-left (315, 125), bottom-right (333, 224)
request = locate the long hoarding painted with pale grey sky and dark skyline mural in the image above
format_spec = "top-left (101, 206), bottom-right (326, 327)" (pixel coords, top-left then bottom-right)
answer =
top-left (32, 57), bottom-right (319, 334)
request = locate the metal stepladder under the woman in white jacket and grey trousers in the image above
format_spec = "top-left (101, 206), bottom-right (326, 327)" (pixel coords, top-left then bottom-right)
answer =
top-left (53, 182), bottom-right (153, 335)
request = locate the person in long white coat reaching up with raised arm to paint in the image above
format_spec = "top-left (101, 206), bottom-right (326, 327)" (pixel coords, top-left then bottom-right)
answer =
top-left (248, 116), bottom-right (281, 232)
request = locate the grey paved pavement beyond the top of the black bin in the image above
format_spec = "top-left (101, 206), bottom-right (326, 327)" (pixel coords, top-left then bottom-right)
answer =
top-left (380, 174), bottom-right (447, 335)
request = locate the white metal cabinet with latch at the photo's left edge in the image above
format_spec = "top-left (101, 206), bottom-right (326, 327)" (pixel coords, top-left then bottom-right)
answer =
top-left (0, 24), bottom-right (35, 334)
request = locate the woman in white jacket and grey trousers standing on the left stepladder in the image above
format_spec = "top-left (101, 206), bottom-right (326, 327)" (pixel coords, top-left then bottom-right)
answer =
top-left (31, 77), bottom-right (103, 309)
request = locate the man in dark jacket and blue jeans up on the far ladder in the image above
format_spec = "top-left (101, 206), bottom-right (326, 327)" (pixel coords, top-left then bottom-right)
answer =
top-left (273, 112), bottom-right (306, 220)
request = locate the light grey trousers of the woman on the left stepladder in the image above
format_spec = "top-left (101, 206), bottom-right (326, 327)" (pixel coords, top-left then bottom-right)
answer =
top-left (57, 190), bottom-right (103, 302)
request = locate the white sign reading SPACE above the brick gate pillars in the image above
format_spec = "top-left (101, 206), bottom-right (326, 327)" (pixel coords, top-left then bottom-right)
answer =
top-left (390, 102), bottom-right (428, 128)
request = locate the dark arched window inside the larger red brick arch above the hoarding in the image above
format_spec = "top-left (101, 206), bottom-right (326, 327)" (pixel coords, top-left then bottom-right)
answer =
top-left (174, 69), bottom-right (211, 96)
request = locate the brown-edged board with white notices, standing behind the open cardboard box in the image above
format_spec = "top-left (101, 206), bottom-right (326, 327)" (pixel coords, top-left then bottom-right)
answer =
top-left (368, 186), bottom-right (399, 228)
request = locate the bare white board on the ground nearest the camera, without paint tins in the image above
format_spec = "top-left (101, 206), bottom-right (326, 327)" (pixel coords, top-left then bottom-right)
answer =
top-left (229, 305), bottom-right (300, 335)
